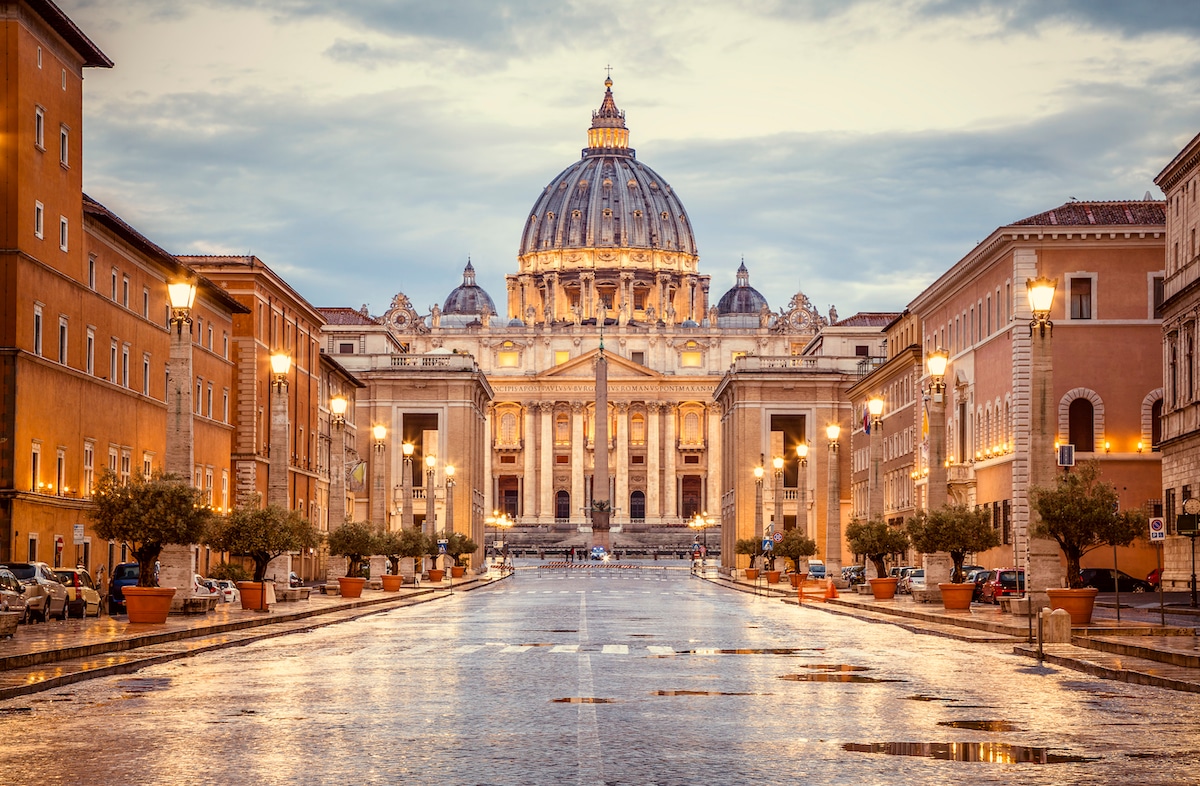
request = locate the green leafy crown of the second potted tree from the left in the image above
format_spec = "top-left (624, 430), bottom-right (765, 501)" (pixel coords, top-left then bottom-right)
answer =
top-left (204, 499), bottom-right (320, 581)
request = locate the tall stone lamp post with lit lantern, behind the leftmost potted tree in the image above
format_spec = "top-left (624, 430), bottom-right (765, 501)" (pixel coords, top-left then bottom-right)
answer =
top-left (165, 281), bottom-right (196, 611)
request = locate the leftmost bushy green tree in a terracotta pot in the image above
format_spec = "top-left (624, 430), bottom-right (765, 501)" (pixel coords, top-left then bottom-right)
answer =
top-left (91, 470), bottom-right (211, 624)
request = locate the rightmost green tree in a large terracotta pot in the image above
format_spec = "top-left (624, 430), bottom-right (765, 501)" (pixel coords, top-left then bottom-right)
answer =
top-left (1030, 461), bottom-right (1146, 625)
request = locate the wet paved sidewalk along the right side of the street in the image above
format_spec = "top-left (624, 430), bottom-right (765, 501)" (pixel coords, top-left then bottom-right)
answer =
top-left (702, 574), bottom-right (1200, 692)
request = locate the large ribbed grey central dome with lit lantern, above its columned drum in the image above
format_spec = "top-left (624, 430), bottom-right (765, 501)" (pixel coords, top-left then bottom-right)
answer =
top-left (520, 79), bottom-right (697, 259)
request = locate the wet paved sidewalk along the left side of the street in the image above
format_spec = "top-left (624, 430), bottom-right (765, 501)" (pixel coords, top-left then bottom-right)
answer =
top-left (0, 576), bottom-right (500, 700)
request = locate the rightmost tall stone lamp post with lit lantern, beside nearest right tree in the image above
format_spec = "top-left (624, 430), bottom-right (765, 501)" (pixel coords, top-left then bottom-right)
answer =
top-left (1025, 276), bottom-right (1061, 614)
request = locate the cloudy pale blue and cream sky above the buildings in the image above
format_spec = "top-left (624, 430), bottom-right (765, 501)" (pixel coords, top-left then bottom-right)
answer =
top-left (58, 0), bottom-right (1200, 316)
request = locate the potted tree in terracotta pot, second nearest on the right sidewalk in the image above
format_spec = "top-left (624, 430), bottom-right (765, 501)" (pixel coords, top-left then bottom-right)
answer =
top-left (906, 505), bottom-right (1000, 611)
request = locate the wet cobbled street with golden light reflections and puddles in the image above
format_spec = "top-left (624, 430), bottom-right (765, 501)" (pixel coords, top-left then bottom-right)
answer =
top-left (0, 568), bottom-right (1200, 786)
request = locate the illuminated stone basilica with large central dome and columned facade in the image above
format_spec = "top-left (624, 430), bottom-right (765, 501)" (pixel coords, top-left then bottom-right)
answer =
top-left (322, 80), bottom-right (882, 566)
